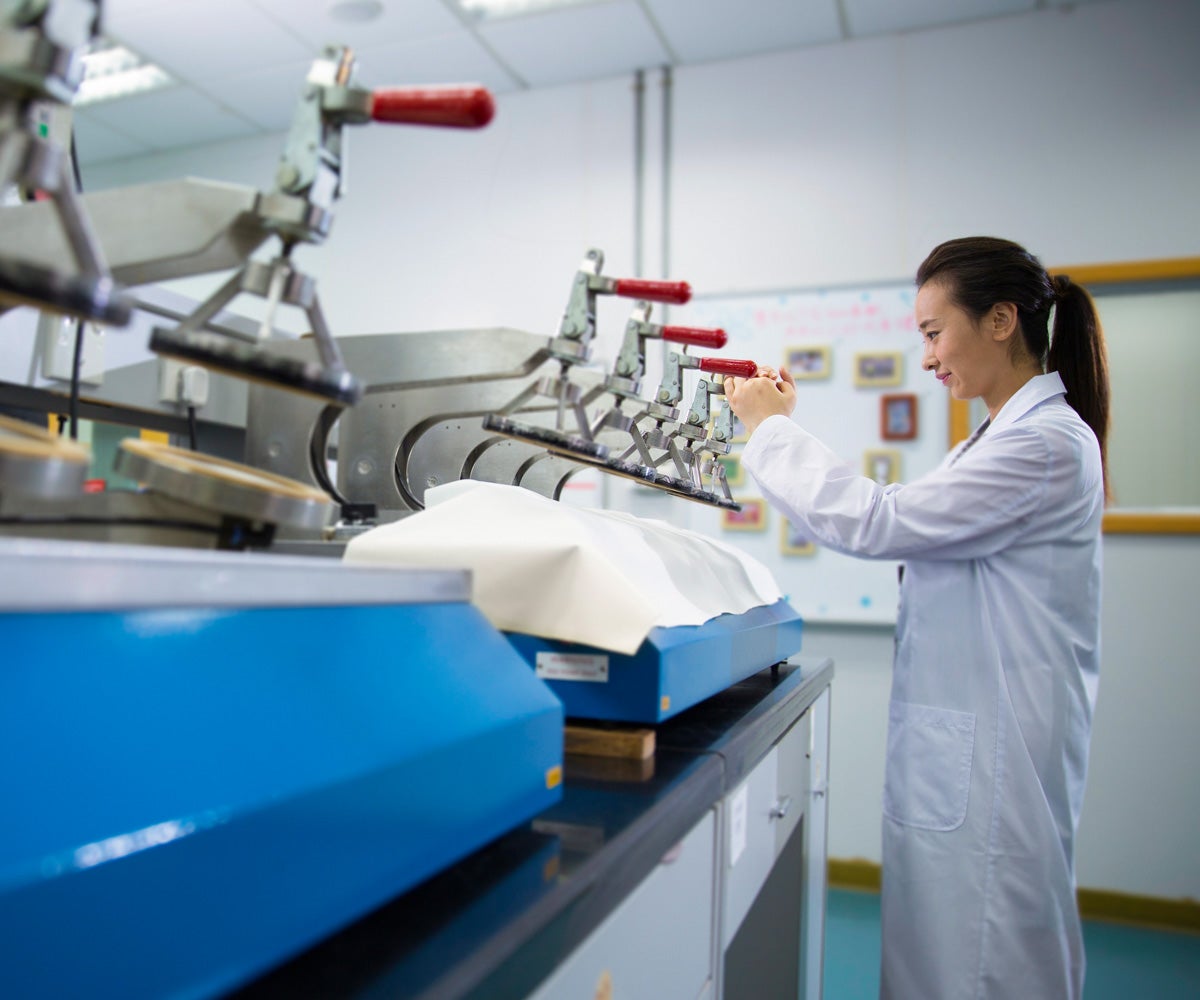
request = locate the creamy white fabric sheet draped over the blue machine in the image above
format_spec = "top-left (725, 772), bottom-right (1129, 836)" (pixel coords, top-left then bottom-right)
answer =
top-left (344, 480), bottom-right (782, 654)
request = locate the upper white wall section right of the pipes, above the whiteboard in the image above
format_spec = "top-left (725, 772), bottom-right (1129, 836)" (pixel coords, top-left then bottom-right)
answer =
top-left (672, 0), bottom-right (1200, 292)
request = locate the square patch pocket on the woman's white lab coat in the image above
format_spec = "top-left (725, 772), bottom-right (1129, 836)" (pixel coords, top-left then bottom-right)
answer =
top-left (883, 701), bottom-right (976, 832)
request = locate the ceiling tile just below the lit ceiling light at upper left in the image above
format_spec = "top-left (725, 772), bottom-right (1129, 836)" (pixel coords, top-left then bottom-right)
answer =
top-left (79, 86), bottom-right (260, 149)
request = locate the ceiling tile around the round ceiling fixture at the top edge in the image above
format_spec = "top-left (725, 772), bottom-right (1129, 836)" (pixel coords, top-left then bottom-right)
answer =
top-left (253, 0), bottom-right (462, 52)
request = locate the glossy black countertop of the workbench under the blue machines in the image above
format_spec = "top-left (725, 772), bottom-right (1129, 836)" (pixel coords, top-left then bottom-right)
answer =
top-left (235, 659), bottom-right (833, 1000)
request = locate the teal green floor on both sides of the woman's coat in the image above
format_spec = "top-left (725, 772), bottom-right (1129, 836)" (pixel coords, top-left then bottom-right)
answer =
top-left (824, 890), bottom-right (1200, 1000)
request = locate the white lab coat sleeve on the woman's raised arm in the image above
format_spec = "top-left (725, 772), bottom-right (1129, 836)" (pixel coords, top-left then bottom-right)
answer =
top-left (742, 415), bottom-right (1051, 559)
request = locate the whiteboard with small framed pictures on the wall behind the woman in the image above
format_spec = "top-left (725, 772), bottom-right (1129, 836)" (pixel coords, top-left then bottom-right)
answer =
top-left (614, 283), bottom-right (949, 624)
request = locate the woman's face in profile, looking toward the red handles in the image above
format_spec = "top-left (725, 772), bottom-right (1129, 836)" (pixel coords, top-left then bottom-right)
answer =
top-left (917, 281), bottom-right (1004, 402)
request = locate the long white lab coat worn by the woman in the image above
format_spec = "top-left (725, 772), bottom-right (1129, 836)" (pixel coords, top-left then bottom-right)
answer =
top-left (743, 373), bottom-right (1104, 1000)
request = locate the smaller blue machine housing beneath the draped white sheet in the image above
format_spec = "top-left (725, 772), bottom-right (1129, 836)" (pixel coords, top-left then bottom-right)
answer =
top-left (506, 600), bottom-right (803, 723)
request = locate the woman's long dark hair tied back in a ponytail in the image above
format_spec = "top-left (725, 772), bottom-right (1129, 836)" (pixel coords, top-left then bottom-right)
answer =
top-left (917, 236), bottom-right (1109, 483)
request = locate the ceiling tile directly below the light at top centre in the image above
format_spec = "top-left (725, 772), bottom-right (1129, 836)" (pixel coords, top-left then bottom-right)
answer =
top-left (478, 0), bottom-right (670, 86)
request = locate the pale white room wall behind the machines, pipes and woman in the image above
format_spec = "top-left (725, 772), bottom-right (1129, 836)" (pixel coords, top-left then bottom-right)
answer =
top-left (85, 0), bottom-right (1200, 898)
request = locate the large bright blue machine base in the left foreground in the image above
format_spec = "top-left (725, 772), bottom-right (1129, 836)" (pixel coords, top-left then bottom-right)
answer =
top-left (0, 603), bottom-right (563, 1000)
